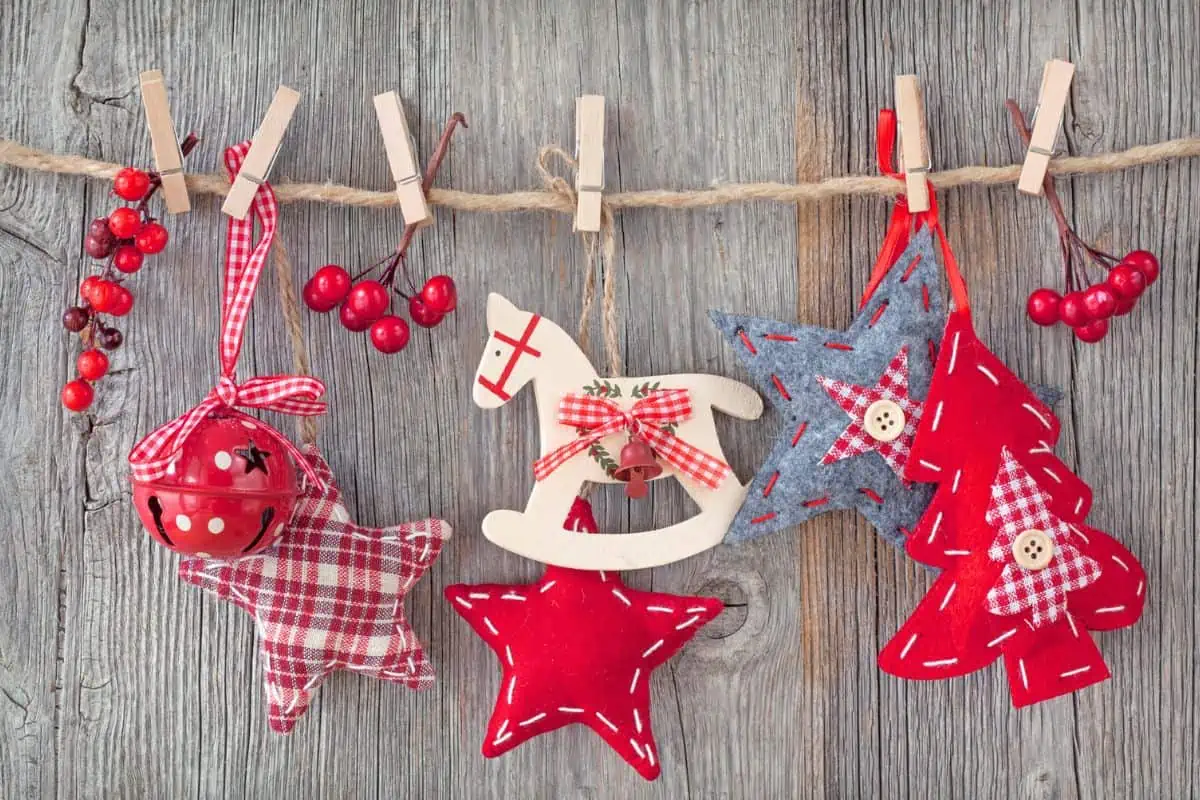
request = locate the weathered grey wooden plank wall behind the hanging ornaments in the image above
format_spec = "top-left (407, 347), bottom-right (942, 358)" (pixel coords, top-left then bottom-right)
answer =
top-left (0, 0), bottom-right (1200, 798)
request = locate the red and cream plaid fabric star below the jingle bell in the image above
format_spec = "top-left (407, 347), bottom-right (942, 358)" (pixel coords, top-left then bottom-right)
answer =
top-left (179, 445), bottom-right (450, 733)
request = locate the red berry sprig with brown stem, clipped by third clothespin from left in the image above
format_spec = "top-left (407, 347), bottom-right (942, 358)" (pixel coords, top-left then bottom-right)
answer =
top-left (301, 113), bottom-right (467, 354)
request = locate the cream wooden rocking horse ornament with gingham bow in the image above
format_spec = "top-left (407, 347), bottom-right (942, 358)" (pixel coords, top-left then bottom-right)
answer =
top-left (473, 294), bottom-right (762, 570)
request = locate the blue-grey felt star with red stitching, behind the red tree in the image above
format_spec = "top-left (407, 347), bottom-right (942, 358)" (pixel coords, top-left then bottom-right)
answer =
top-left (712, 225), bottom-right (946, 545)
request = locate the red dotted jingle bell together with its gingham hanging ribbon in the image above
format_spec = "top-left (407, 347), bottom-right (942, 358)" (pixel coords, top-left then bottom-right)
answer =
top-left (130, 142), bottom-right (325, 557)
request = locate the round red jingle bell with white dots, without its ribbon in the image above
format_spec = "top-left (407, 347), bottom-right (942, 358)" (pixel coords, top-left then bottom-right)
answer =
top-left (133, 415), bottom-right (300, 558)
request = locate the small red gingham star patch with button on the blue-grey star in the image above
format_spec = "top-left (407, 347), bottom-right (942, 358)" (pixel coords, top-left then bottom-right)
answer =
top-left (817, 347), bottom-right (922, 477)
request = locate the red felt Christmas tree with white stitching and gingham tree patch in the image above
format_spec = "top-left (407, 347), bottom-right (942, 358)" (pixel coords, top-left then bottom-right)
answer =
top-left (880, 311), bottom-right (1146, 706)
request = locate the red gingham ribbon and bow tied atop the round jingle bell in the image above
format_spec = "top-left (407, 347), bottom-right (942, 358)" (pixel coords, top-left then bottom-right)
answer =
top-left (130, 142), bottom-right (325, 482)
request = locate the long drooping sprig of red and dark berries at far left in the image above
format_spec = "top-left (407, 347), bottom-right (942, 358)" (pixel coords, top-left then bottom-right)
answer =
top-left (62, 134), bottom-right (200, 411)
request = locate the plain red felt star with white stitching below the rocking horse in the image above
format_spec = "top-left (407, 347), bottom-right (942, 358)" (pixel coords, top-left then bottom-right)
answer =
top-left (445, 499), bottom-right (724, 781)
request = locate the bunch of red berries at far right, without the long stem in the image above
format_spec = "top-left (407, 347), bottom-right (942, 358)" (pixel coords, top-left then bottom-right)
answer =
top-left (1025, 248), bottom-right (1158, 344)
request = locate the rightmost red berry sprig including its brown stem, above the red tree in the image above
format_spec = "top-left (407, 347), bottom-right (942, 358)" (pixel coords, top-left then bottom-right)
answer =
top-left (1006, 100), bottom-right (1159, 344)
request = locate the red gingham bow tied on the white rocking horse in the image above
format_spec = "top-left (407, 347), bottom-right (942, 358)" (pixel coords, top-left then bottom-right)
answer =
top-left (533, 389), bottom-right (730, 489)
